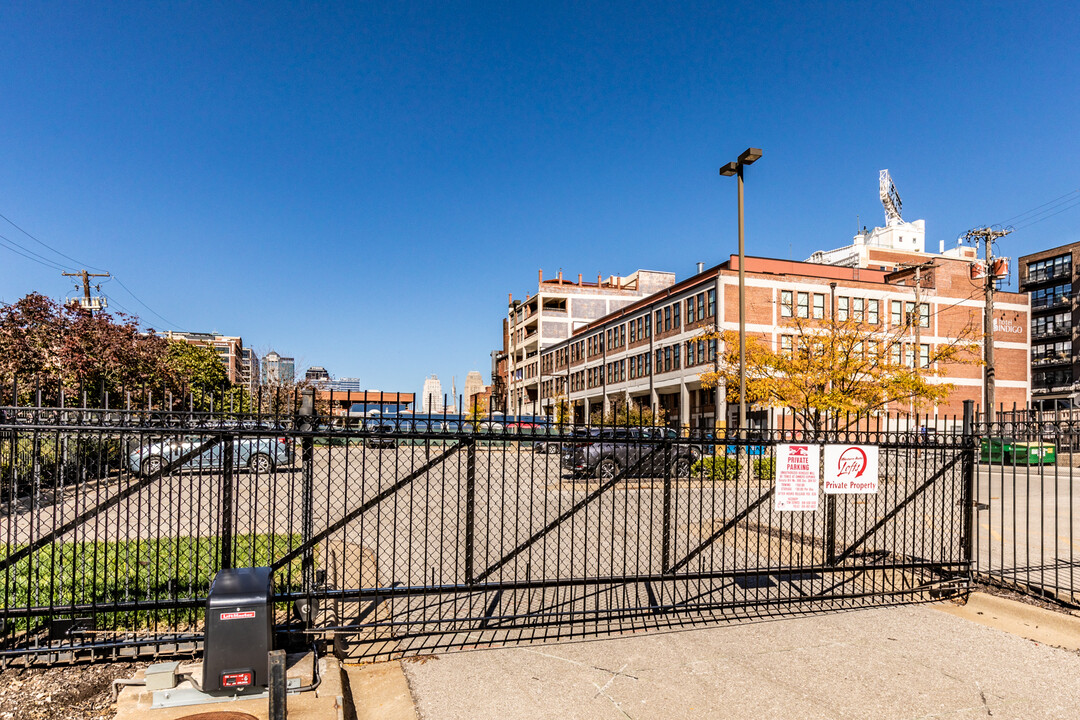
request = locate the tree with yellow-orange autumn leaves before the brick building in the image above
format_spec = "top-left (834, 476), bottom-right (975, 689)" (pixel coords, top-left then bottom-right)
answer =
top-left (699, 316), bottom-right (980, 430)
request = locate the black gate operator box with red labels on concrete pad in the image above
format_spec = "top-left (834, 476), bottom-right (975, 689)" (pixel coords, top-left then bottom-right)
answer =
top-left (202, 568), bottom-right (273, 692)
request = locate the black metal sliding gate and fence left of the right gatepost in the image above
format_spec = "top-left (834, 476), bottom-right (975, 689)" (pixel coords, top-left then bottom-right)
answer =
top-left (0, 388), bottom-right (989, 662)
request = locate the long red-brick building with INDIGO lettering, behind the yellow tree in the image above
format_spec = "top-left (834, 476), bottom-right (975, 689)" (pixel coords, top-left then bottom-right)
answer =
top-left (530, 247), bottom-right (1029, 427)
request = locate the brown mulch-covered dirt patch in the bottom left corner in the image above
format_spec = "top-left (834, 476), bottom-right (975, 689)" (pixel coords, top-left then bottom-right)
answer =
top-left (0, 663), bottom-right (148, 720)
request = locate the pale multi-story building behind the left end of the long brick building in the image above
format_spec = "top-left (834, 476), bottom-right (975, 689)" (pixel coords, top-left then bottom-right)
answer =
top-left (505, 270), bottom-right (675, 415)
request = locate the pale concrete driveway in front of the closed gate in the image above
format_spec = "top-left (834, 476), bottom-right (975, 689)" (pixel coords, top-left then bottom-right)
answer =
top-left (403, 606), bottom-right (1080, 720)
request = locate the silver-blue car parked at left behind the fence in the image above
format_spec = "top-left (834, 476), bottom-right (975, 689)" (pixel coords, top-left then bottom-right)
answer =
top-left (127, 435), bottom-right (294, 475)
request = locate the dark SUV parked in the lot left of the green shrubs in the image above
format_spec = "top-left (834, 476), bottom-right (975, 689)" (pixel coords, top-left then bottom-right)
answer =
top-left (563, 427), bottom-right (700, 479)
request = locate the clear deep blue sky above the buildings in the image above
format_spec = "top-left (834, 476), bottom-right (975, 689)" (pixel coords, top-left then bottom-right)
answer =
top-left (0, 2), bottom-right (1080, 399)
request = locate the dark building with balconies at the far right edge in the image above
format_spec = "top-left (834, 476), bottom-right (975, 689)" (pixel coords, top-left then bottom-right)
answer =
top-left (1020, 243), bottom-right (1080, 410)
